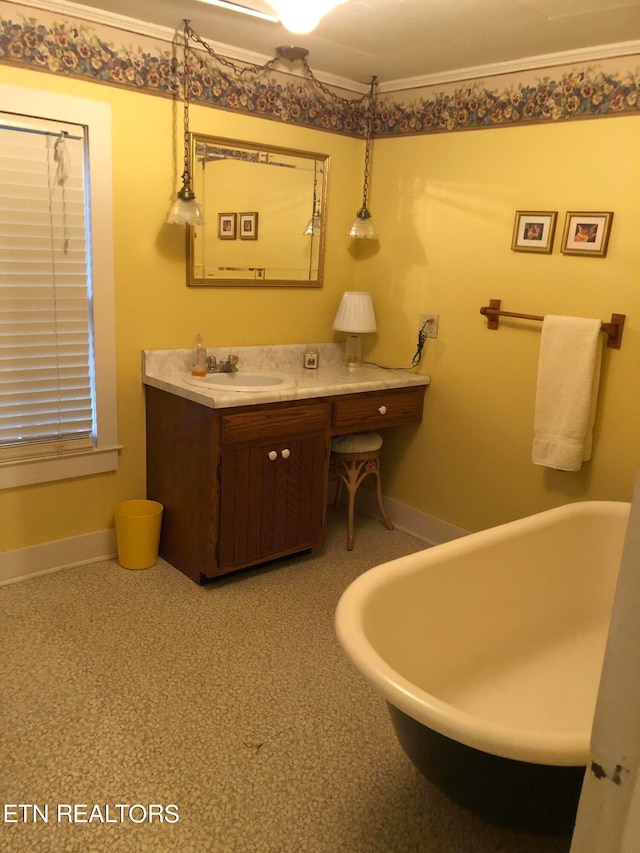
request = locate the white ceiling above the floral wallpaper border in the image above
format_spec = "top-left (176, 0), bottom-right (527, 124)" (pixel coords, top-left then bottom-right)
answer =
top-left (65, 0), bottom-right (640, 88)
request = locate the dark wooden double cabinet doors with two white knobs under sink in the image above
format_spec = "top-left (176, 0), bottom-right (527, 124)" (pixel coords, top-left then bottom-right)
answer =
top-left (219, 434), bottom-right (328, 570)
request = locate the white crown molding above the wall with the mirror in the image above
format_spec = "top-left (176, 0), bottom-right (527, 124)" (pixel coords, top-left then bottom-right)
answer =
top-left (15, 0), bottom-right (369, 94)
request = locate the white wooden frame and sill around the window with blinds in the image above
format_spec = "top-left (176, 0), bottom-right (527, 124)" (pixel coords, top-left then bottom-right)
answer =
top-left (0, 83), bottom-right (121, 489)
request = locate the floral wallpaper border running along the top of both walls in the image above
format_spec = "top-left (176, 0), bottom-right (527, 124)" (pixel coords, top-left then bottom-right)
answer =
top-left (0, 2), bottom-right (640, 137)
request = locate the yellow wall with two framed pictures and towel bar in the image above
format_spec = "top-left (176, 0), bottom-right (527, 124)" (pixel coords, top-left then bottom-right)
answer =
top-left (356, 117), bottom-right (640, 530)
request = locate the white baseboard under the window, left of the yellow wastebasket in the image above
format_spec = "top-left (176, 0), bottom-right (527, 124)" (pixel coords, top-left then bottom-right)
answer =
top-left (0, 528), bottom-right (117, 586)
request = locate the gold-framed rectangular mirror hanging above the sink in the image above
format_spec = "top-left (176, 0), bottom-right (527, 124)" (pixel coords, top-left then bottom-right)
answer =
top-left (187, 133), bottom-right (329, 287)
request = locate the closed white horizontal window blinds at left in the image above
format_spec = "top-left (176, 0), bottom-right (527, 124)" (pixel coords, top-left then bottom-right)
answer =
top-left (0, 113), bottom-right (95, 461)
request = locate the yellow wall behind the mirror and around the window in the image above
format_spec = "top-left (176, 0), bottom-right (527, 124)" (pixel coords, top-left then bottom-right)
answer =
top-left (0, 65), bottom-right (363, 550)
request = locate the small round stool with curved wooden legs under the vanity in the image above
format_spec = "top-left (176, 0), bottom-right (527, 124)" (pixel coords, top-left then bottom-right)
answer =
top-left (330, 432), bottom-right (394, 551)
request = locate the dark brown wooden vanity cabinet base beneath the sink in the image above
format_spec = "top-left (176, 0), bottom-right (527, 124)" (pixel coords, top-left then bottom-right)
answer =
top-left (146, 386), bottom-right (330, 583)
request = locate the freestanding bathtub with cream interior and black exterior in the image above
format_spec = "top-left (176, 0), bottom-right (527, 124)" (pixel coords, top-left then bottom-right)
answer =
top-left (336, 501), bottom-right (630, 832)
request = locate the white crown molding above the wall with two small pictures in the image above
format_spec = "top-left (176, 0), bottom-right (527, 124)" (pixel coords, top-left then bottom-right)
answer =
top-left (378, 39), bottom-right (640, 94)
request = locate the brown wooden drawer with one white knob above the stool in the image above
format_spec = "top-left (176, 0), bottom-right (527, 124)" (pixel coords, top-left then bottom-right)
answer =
top-left (331, 385), bottom-right (426, 435)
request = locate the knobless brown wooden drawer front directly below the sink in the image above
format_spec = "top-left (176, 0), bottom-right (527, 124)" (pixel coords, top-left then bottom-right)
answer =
top-left (222, 401), bottom-right (329, 445)
